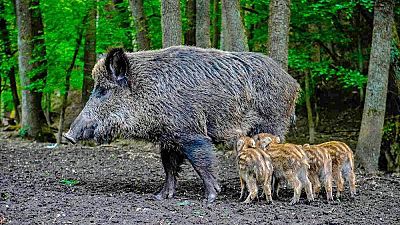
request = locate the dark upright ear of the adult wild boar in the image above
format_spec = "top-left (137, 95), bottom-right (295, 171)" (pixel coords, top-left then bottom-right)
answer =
top-left (105, 48), bottom-right (129, 86)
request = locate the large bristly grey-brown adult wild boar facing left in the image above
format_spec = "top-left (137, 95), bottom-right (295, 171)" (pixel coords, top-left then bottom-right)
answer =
top-left (65, 46), bottom-right (299, 202)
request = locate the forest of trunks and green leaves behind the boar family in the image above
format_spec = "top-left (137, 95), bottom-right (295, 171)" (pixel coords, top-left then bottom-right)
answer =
top-left (0, 0), bottom-right (400, 172)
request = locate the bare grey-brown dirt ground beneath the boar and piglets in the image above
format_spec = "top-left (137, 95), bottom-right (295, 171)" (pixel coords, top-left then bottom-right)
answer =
top-left (0, 133), bottom-right (400, 225)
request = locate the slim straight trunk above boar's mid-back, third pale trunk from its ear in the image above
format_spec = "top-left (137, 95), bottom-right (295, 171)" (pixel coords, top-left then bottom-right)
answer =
top-left (196, 0), bottom-right (211, 48)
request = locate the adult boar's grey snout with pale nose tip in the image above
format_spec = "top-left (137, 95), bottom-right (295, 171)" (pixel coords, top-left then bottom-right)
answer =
top-left (63, 115), bottom-right (97, 144)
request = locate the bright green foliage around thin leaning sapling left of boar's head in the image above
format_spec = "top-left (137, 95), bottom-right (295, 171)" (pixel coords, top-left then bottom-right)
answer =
top-left (41, 0), bottom-right (87, 93)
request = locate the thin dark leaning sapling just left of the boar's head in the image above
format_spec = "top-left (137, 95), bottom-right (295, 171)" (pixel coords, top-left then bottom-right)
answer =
top-left (57, 17), bottom-right (85, 144)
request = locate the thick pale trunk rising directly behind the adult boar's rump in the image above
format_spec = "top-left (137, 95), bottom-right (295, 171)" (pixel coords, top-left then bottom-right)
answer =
top-left (267, 0), bottom-right (290, 71)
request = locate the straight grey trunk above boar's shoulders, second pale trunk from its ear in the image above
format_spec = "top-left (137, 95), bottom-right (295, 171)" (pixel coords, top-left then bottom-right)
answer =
top-left (161, 0), bottom-right (182, 48)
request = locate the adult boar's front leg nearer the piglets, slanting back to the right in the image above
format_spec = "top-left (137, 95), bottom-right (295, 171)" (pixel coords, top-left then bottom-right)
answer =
top-left (181, 135), bottom-right (221, 202)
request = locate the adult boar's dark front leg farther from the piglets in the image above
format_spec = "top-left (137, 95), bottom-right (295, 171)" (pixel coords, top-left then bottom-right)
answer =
top-left (156, 145), bottom-right (184, 200)
